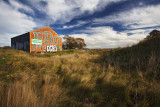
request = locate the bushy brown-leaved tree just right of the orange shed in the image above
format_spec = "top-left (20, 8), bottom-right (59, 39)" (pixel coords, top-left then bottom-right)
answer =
top-left (63, 35), bottom-right (86, 49)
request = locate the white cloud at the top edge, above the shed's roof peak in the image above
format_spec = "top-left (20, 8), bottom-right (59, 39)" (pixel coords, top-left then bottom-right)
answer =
top-left (46, 0), bottom-right (98, 23)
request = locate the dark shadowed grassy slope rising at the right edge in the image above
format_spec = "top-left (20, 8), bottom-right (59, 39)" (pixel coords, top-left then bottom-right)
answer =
top-left (101, 30), bottom-right (160, 72)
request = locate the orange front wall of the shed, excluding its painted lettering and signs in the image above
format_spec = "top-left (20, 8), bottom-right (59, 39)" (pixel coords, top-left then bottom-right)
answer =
top-left (30, 26), bottom-right (62, 52)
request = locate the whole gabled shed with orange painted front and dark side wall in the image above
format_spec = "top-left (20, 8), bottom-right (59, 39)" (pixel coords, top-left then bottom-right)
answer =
top-left (11, 26), bottom-right (62, 53)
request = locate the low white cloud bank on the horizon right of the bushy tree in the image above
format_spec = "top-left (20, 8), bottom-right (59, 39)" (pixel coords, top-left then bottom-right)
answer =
top-left (61, 27), bottom-right (148, 48)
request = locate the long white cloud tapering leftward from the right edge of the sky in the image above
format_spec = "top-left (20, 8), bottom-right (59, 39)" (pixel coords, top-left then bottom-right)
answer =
top-left (93, 5), bottom-right (160, 29)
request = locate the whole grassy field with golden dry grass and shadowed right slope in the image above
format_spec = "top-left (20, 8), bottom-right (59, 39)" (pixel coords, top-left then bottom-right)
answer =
top-left (0, 31), bottom-right (160, 107)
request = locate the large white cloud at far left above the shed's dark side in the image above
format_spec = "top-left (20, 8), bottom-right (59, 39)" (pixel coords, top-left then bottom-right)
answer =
top-left (0, 1), bottom-right (36, 46)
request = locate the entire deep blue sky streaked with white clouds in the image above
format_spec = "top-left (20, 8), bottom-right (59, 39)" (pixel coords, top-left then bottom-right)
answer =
top-left (0, 0), bottom-right (160, 49)
